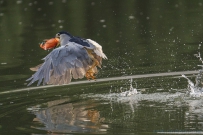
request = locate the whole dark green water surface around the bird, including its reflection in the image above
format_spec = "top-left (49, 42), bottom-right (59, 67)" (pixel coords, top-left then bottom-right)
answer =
top-left (0, 0), bottom-right (203, 135)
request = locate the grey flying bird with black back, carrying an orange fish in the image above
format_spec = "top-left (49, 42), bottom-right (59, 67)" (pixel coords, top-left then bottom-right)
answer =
top-left (26, 31), bottom-right (107, 86)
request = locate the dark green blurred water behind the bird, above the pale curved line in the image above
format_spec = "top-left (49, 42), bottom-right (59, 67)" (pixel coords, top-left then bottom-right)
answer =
top-left (0, 0), bottom-right (203, 91)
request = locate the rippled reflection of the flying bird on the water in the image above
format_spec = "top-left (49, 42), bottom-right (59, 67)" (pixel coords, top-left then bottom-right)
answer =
top-left (28, 99), bottom-right (108, 133)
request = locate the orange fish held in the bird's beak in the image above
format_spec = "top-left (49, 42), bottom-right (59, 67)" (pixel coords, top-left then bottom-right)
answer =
top-left (40, 38), bottom-right (59, 50)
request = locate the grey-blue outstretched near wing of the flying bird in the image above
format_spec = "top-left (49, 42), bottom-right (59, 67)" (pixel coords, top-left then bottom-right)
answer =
top-left (27, 42), bottom-right (94, 86)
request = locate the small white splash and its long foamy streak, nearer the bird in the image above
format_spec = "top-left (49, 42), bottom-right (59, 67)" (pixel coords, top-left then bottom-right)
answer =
top-left (82, 78), bottom-right (185, 104)
